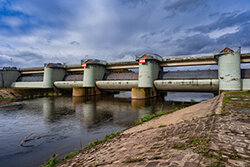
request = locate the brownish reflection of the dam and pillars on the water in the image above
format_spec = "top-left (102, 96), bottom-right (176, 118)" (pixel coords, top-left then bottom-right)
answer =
top-left (42, 96), bottom-right (186, 127)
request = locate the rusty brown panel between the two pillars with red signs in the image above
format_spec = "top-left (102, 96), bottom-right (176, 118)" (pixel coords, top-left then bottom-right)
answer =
top-left (106, 73), bottom-right (138, 80)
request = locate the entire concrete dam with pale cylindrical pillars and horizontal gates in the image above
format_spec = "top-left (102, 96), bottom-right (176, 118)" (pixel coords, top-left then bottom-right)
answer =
top-left (0, 48), bottom-right (250, 99)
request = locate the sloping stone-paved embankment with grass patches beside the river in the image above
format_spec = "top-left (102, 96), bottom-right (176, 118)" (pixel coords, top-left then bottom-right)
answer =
top-left (58, 92), bottom-right (250, 167)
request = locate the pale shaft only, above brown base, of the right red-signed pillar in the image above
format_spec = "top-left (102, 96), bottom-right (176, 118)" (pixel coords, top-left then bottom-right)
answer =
top-left (138, 59), bottom-right (160, 88)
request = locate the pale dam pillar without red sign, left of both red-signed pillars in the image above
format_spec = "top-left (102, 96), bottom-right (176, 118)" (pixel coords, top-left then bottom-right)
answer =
top-left (43, 63), bottom-right (66, 88)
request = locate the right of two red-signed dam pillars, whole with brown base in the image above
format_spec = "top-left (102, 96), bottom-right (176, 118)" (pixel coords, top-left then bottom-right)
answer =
top-left (131, 54), bottom-right (162, 99)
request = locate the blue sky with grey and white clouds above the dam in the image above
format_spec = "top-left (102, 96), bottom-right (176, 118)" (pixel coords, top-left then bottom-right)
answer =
top-left (0, 0), bottom-right (250, 67)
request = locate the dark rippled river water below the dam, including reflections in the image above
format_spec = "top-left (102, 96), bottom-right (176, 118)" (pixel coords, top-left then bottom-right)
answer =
top-left (0, 93), bottom-right (213, 167)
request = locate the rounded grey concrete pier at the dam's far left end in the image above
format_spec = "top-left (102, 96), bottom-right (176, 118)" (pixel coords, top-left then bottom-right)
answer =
top-left (0, 71), bottom-right (20, 88)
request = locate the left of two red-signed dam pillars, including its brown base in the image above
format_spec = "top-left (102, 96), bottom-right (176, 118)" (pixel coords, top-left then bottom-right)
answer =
top-left (72, 59), bottom-right (106, 97)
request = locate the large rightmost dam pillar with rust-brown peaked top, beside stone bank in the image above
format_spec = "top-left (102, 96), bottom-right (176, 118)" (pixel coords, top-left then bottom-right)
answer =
top-left (215, 48), bottom-right (242, 91)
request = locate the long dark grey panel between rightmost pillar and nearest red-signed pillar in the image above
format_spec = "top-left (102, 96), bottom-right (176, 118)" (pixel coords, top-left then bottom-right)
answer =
top-left (159, 70), bottom-right (218, 80)
